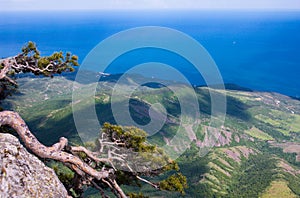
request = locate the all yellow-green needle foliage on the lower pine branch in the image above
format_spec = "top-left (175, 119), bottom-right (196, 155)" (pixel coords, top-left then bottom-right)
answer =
top-left (98, 123), bottom-right (187, 196)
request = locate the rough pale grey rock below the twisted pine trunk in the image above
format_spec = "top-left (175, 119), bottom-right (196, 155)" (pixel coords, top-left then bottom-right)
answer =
top-left (0, 133), bottom-right (68, 198)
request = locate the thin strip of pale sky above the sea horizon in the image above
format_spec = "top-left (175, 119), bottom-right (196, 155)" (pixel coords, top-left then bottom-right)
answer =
top-left (0, 0), bottom-right (300, 11)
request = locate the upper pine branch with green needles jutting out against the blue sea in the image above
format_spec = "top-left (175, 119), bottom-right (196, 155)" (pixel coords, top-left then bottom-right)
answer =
top-left (0, 41), bottom-right (79, 100)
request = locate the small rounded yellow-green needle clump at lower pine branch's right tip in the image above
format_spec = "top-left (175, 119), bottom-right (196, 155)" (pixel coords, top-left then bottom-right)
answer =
top-left (159, 173), bottom-right (188, 194)
